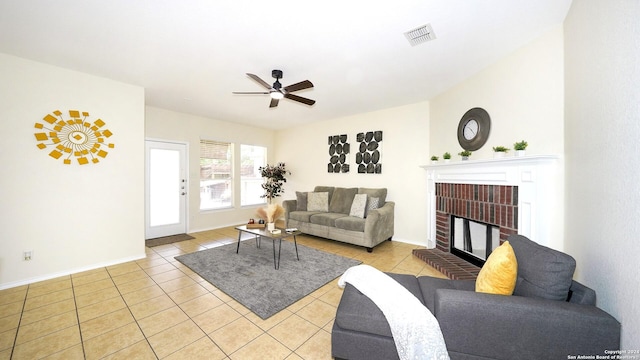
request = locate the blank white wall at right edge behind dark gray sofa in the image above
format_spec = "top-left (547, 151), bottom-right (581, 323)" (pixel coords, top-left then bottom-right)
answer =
top-left (564, 0), bottom-right (640, 350)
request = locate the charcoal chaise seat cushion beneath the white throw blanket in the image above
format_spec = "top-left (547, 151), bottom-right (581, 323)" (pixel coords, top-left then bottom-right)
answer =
top-left (335, 273), bottom-right (422, 337)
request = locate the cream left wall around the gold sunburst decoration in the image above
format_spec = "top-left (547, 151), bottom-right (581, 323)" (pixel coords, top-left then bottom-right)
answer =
top-left (0, 54), bottom-right (145, 288)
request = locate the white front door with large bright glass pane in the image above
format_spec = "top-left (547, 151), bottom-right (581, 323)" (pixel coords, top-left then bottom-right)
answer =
top-left (145, 140), bottom-right (188, 239)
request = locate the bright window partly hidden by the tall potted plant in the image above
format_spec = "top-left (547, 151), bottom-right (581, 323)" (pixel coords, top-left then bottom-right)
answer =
top-left (240, 145), bottom-right (267, 206)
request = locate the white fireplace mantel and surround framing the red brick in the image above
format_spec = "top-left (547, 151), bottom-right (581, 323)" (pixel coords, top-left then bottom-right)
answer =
top-left (421, 155), bottom-right (563, 249)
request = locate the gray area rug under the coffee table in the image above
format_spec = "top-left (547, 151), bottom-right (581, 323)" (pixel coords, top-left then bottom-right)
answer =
top-left (175, 238), bottom-right (360, 319)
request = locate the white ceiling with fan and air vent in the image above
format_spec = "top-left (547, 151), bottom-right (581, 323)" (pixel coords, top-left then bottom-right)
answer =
top-left (0, 0), bottom-right (571, 129)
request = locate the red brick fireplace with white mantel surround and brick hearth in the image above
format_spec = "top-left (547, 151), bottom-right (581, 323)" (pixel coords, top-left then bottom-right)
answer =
top-left (414, 155), bottom-right (562, 279)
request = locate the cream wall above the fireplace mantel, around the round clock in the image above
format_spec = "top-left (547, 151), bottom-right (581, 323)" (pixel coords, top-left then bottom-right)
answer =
top-left (429, 26), bottom-right (564, 250)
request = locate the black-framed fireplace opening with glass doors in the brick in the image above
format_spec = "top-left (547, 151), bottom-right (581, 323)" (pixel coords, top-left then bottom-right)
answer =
top-left (449, 215), bottom-right (500, 267)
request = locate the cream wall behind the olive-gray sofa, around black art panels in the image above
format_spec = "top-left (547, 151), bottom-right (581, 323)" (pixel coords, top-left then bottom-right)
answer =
top-left (275, 102), bottom-right (429, 246)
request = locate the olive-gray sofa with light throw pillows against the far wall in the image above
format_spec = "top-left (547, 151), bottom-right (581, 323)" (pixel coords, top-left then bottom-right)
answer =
top-left (282, 186), bottom-right (395, 252)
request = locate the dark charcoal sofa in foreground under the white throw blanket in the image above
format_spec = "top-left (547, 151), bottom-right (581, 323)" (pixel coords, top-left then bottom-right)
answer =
top-left (331, 235), bottom-right (621, 360)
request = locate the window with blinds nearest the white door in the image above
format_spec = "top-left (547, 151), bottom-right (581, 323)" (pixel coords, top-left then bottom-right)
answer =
top-left (200, 140), bottom-right (233, 210)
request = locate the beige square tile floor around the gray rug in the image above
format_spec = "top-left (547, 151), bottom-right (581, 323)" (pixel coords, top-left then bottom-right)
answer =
top-left (0, 227), bottom-right (444, 360)
